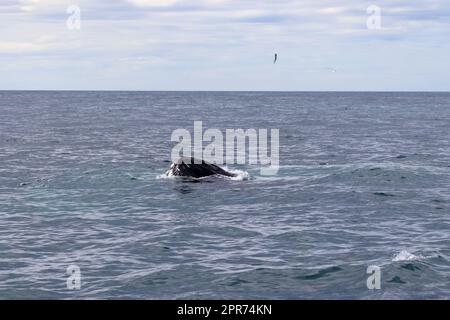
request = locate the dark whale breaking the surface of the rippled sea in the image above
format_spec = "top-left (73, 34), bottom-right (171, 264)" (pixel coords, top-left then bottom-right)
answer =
top-left (166, 158), bottom-right (237, 178)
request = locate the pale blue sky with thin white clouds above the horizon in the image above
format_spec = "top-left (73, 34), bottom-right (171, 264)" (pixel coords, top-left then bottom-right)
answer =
top-left (0, 0), bottom-right (450, 91)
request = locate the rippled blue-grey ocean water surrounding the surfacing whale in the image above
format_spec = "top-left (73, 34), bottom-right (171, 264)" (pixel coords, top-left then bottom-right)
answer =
top-left (0, 92), bottom-right (450, 299)
